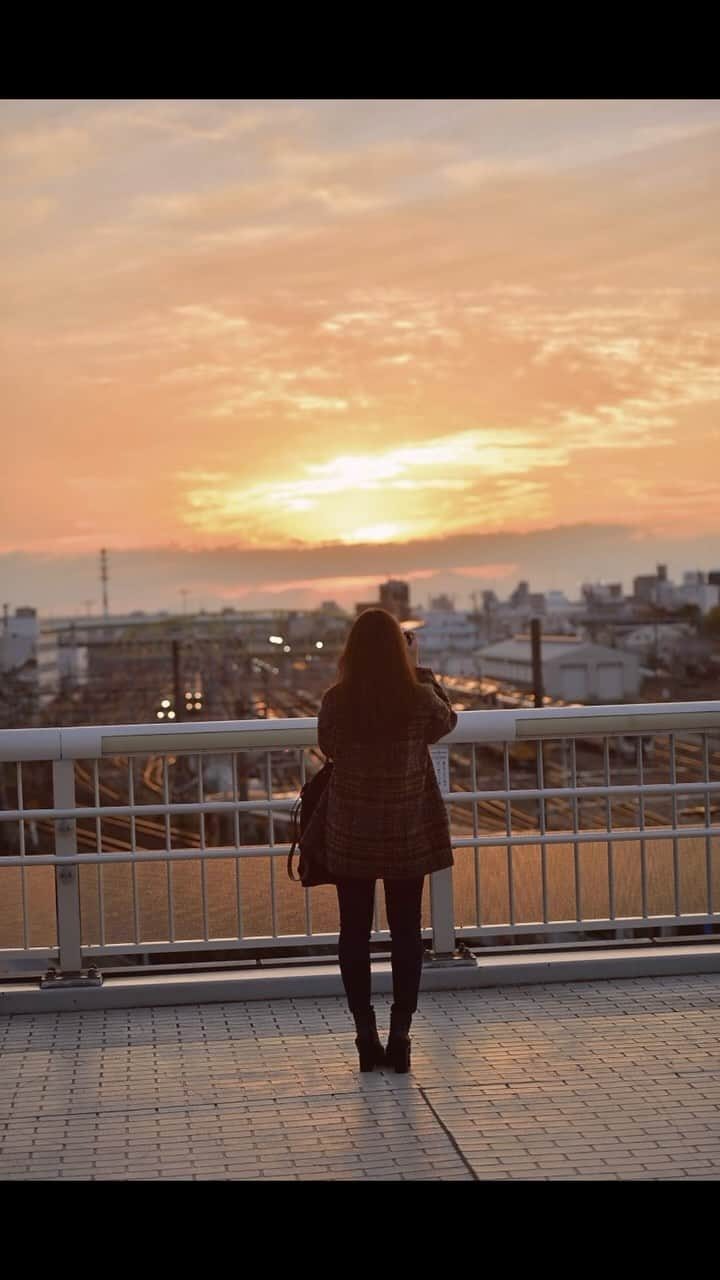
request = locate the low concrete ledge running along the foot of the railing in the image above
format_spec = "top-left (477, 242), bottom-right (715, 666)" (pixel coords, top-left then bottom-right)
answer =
top-left (0, 943), bottom-right (720, 1016)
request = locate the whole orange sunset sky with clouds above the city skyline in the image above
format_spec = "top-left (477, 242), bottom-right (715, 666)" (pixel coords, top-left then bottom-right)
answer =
top-left (0, 99), bottom-right (720, 613)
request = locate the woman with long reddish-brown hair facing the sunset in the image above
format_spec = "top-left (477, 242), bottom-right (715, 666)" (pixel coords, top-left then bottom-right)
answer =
top-left (318, 609), bottom-right (457, 1071)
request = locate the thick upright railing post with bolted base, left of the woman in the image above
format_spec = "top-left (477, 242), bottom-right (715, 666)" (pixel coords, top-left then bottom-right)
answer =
top-left (40, 760), bottom-right (102, 988)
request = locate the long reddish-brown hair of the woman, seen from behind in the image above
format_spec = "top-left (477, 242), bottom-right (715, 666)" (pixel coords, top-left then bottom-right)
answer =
top-left (338, 609), bottom-right (418, 739)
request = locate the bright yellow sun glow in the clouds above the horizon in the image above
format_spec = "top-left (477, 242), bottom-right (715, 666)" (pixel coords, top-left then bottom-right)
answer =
top-left (178, 428), bottom-right (561, 544)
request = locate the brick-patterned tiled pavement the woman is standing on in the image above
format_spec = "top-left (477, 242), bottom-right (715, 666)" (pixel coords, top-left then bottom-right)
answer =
top-left (0, 974), bottom-right (720, 1181)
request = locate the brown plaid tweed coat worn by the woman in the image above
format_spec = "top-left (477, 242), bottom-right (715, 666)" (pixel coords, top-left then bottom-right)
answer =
top-left (311, 667), bottom-right (457, 879)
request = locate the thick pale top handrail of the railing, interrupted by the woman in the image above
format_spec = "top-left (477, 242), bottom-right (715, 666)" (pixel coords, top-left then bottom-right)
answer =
top-left (0, 701), bottom-right (720, 762)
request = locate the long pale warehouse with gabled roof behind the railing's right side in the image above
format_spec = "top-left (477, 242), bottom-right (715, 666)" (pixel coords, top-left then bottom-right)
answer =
top-left (477, 636), bottom-right (641, 704)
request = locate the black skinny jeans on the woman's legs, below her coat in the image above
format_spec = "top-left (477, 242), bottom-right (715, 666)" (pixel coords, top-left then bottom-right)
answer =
top-left (337, 876), bottom-right (425, 1014)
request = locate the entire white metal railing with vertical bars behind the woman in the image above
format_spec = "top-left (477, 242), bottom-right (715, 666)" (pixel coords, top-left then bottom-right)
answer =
top-left (0, 701), bottom-right (720, 974)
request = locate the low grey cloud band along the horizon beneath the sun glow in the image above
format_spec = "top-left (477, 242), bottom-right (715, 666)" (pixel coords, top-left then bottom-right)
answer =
top-left (0, 524), bottom-right (717, 613)
